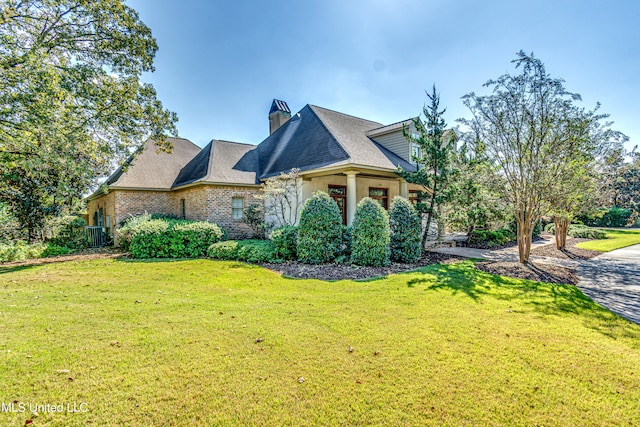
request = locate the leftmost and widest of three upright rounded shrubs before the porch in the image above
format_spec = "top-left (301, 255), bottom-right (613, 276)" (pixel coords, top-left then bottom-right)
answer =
top-left (297, 191), bottom-right (342, 264)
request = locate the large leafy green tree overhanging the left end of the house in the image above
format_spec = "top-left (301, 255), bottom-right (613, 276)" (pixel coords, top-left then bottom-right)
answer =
top-left (0, 0), bottom-right (177, 236)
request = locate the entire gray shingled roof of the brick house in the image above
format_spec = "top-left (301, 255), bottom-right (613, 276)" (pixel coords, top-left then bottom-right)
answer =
top-left (97, 100), bottom-right (415, 189)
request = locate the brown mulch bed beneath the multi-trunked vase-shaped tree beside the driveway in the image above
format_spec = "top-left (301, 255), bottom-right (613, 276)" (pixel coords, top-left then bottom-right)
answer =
top-left (476, 261), bottom-right (578, 285)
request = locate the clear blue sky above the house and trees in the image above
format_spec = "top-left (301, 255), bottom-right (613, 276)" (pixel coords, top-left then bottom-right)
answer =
top-left (128, 0), bottom-right (640, 152)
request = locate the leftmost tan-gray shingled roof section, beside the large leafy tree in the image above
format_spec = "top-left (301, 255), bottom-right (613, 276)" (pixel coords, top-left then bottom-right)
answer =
top-left (107, 138), bottom-right (200, 190)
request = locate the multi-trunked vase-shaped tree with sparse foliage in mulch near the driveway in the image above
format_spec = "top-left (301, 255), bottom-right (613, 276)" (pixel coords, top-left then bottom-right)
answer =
top-left (461, 51), bottom-right (624, 264)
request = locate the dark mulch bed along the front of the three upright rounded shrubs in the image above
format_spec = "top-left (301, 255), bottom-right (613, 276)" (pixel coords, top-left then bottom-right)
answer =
top-left (259, 252), bottom-right (464, 280)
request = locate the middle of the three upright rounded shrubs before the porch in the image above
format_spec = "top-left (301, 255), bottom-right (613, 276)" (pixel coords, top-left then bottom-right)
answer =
top-left (351, 197), bottom-right (390, 267)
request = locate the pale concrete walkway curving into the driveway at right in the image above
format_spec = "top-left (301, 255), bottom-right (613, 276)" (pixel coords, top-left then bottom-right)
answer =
top-left (433, 241), bottom-right (640, 324)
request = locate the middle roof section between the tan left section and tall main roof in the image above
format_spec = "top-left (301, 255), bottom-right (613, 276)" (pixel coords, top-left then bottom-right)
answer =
top-left (173, 139), bottom-right (258, 188)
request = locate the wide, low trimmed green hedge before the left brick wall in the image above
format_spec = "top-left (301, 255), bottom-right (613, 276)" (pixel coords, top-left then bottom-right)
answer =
top-left (125, 219), bottom-right (224, 258)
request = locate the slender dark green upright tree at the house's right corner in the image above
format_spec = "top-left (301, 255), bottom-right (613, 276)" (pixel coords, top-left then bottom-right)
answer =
top-left (397, 85), bottom-right (456, 247)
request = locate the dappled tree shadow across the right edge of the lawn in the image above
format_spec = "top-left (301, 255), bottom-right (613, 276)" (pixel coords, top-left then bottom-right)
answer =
top-left (416, 262), bottom-right (640, 342)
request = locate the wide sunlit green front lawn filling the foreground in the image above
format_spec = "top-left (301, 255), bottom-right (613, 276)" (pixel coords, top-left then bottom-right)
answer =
top-left (0, 260), bottom-right (640, 426)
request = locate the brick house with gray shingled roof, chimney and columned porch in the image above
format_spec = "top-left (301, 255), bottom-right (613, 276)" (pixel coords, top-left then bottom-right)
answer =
top-left (87, 100), bottom-right (419, 242)
